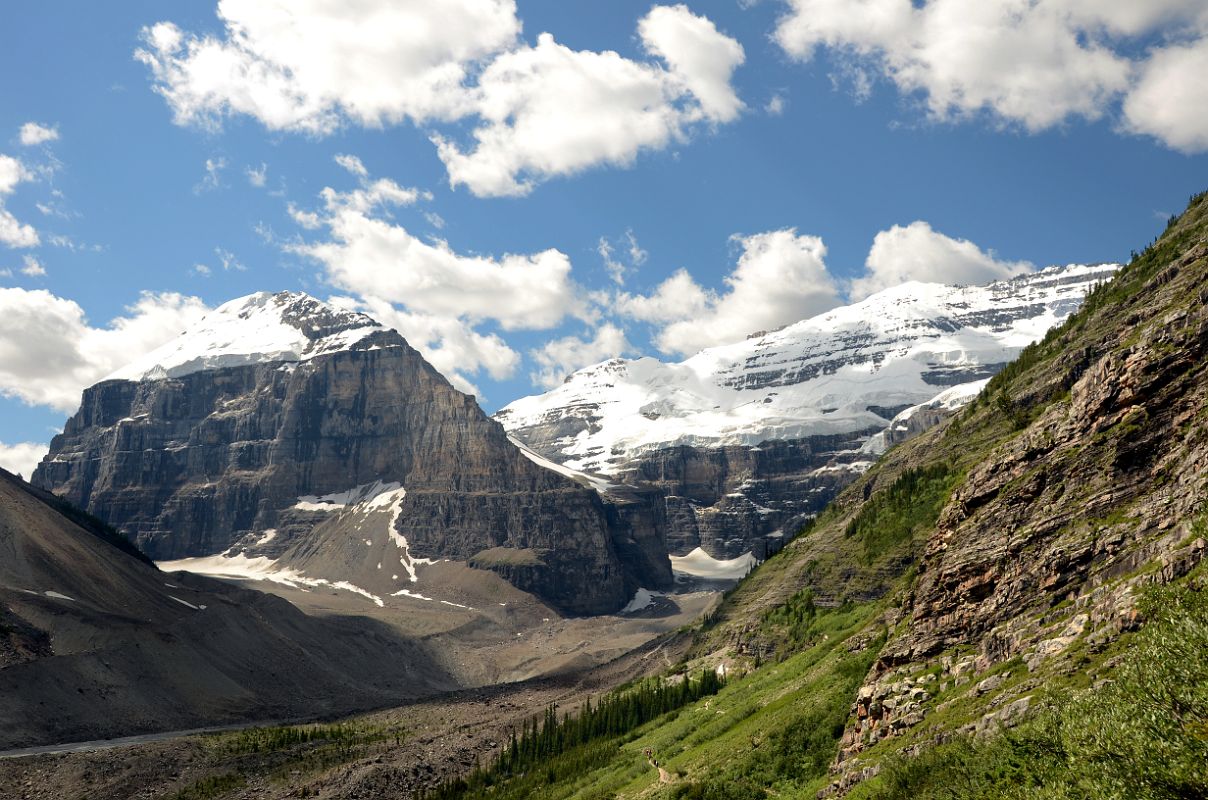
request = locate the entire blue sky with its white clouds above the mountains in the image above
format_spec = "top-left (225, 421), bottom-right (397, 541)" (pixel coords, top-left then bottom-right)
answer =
top-left (0, 0), bottom-right (1208, 476)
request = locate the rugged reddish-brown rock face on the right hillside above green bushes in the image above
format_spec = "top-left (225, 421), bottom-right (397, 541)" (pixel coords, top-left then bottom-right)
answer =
top-left (836, 196), bottom-right (1208, 788)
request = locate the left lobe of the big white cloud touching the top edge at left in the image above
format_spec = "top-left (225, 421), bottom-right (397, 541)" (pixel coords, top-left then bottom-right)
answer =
top-left (137, 0), bottom-right (521, 133)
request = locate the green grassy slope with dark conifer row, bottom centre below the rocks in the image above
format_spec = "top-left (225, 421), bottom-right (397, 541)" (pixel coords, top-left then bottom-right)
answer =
top-left (413, 603), bottom-right (884, 800)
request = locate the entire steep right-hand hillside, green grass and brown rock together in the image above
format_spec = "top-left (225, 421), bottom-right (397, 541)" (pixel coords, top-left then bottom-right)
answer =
top-left (398, 196), bottom-right (1208, 800)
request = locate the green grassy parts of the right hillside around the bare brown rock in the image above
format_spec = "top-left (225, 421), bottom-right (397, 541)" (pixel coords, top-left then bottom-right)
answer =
top-left (398, 197), bottom-right (1208, 800)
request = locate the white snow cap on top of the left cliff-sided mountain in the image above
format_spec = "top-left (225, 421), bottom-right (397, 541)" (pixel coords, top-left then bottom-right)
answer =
top-left (105, 291), bottom-right (383, 381)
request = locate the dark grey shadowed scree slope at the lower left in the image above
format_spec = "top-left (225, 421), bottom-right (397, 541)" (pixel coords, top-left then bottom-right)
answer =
top-left (0, 470), bottom-right (454, 748)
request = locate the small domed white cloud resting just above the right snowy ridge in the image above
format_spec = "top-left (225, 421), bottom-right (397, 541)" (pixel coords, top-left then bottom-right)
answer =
top-left (850, 221), bottom-right (1035, 300)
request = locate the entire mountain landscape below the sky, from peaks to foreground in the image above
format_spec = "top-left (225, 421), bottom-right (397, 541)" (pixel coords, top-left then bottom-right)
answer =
top-left (0, 196), bottom-right (1208, 800)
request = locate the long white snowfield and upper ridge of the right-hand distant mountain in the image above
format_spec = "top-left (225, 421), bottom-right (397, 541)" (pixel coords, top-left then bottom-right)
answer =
top-left (495, 265), bottom-right (1119, 475)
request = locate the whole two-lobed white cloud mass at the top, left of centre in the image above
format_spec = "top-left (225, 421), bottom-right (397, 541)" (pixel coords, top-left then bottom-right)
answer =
top-left (135, 0), bottom-right (745, 196)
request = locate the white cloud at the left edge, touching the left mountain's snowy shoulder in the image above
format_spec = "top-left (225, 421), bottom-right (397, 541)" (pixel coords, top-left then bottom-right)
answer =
top-left (0, 289), bottom-right (208, 412)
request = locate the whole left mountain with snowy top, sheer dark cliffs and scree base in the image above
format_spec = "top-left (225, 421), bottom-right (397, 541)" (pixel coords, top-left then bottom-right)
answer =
top-left (31, 292), bottom-right (672, 614)
